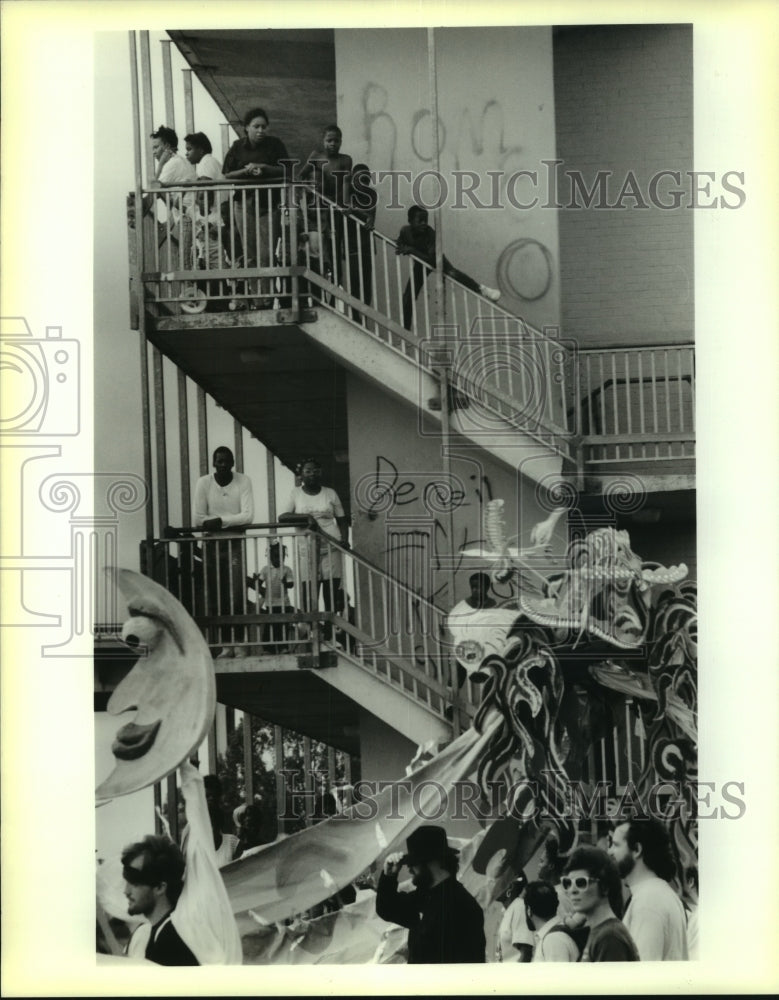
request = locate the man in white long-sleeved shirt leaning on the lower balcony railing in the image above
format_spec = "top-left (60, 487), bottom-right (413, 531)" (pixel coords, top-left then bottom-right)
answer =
top-left (194, 446), bottom-right (254, 659)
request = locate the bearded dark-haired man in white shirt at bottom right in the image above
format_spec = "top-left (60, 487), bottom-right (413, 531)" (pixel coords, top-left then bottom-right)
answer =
top-left (609, 818), bottom-right (689, 962)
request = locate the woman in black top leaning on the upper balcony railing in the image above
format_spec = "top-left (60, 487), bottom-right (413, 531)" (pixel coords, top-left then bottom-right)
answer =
top-left (222, 108), bottom-right (289, 304)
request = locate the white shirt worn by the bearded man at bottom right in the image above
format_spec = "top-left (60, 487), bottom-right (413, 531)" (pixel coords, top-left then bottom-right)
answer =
top-left (623, 875), bottom-right (689, 962)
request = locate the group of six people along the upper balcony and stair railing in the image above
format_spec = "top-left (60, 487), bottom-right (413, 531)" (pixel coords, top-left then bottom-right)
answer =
top-left (151, 107), bottom-right (500, 316)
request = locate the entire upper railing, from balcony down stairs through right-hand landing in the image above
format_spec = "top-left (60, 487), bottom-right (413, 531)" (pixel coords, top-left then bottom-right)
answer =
top-left (131, 184), bottom-right (695, 467)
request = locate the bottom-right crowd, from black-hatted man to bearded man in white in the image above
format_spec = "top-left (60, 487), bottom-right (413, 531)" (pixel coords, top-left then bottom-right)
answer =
top-left (376, 818), bottom-right (695, 964)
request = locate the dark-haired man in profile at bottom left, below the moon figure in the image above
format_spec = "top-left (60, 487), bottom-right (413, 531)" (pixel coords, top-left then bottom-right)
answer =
top-left (122, 835), bottom-right (200, 965)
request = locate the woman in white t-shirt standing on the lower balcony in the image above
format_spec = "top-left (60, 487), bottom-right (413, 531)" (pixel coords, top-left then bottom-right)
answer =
top-left (279, 458), bottom-right (349, 638)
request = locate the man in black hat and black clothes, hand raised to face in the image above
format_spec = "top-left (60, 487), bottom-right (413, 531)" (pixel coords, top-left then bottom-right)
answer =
top-left (376, 825), bottom-right (486, 965)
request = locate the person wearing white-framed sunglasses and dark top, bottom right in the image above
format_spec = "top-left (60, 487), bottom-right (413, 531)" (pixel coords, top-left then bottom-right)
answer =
top-left (560, 847), bottom-right (639, 962)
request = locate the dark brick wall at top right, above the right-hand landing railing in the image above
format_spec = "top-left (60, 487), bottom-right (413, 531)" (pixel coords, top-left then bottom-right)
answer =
top-left (554, 24), bottom-right (696, 346)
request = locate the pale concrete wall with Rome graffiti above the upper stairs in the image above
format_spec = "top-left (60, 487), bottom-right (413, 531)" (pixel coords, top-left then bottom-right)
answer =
top-left (335, 27), bottom-right (559, 326)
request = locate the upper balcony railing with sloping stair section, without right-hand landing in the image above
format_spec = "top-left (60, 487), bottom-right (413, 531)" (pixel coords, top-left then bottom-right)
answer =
top-left (133, 184), bottom-right (571, 455)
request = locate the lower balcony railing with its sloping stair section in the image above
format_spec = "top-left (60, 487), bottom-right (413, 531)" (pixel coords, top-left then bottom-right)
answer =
top-left (142, 524), bottom-right (478, 719)
